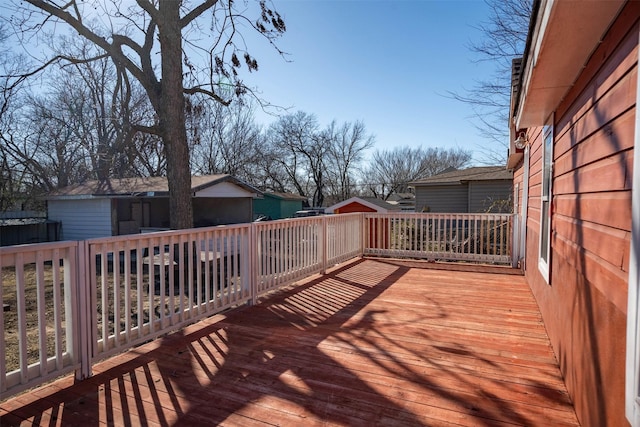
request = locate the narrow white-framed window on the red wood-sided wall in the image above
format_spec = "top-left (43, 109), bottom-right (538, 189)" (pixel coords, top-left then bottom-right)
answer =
top-left (538, 126), bottom-right (553, 283)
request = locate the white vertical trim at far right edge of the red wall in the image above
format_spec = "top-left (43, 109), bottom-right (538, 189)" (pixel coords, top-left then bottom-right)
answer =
top-left (625, 27), bottom-right (640, 427)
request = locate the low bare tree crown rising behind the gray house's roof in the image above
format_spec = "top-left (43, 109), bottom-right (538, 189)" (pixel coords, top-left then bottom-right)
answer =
top-left (365, 147), bottom-right (471, 200)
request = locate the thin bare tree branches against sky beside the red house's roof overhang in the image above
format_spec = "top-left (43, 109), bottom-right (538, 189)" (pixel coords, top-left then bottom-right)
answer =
top-left (450, 0), bottom-right (533, 165)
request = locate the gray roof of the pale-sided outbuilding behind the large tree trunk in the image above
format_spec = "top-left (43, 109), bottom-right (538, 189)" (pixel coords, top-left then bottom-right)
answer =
top-left (47, 174), bottom-right (262, 199)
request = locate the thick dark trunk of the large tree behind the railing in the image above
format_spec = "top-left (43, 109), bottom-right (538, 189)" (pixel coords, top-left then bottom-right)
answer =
top-left (158, 0), bottom-right (193, 229)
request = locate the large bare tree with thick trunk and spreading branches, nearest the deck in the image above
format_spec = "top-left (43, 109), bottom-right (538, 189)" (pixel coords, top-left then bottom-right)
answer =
top-left (6, 0), bottom-right (285, 228)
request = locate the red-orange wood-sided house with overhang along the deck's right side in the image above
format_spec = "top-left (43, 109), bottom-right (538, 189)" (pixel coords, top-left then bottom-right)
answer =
top-left (505, 0), bottom-right (640, 427)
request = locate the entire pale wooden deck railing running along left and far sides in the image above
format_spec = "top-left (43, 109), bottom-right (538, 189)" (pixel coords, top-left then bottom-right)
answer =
top-left (0, 214), bottom-right (510, 399)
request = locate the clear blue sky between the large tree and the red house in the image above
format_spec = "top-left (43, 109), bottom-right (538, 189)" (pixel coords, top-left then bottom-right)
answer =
top-left (245, 0), bottom-right (506, 165)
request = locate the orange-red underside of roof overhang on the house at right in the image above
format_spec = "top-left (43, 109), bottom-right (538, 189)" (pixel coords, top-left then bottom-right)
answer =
top-left (514, 0), bottom-right (625, 129)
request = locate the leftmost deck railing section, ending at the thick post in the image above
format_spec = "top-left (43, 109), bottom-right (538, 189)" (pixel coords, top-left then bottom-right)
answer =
top-left (0, 242), bottom-right (84, 398)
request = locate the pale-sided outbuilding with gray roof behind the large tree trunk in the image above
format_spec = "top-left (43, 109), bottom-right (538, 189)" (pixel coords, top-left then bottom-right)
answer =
top-left (47, 175), bottom-right (262, 240)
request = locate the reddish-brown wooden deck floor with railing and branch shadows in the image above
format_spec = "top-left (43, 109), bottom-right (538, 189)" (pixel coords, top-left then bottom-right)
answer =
top-left (0, 259), bottom-right (578, 427)
